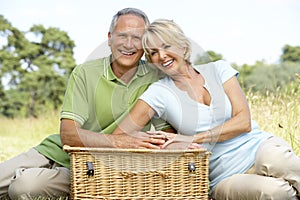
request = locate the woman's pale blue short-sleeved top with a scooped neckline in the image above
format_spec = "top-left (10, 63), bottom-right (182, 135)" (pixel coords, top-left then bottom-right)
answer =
top-left (140, 60), bottom-right (271, 191)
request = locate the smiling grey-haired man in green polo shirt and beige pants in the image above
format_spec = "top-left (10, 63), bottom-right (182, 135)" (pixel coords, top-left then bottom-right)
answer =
top-left (0, 8), bottom-right (171, 199)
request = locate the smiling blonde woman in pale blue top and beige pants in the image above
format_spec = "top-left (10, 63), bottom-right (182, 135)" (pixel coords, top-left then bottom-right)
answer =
top-left (115, 20), bottom-right (300, 200)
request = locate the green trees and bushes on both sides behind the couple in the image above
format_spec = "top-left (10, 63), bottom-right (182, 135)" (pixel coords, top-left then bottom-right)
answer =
top-left (0, 15), bottom-right (300, 118)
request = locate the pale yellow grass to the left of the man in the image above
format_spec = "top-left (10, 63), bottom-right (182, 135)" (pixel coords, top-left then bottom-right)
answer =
top-left (0, 111), bottom-right (59, 162)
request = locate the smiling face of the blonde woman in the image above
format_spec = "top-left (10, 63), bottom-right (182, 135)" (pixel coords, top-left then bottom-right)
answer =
top-left (149, 38), bottom-right (186, 76)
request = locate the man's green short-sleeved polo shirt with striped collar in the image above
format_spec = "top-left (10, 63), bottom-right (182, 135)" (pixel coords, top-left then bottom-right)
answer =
top-left (36, 57), bottom-right (169, 168)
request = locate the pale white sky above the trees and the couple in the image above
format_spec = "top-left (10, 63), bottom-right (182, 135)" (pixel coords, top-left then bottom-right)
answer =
top-left (0, 0), bottom-right (300, 65)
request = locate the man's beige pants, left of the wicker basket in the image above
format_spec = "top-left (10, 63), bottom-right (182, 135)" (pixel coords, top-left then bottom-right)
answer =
top-left (0, 148), bottom-right (70, 199)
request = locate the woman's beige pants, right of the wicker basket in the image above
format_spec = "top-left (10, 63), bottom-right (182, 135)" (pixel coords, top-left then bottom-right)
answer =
top-left (212, 137), bottom-right (300, 200)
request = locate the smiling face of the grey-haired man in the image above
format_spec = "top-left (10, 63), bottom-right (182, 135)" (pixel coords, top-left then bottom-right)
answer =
top-left (108, 14), bottom-right (145, 69)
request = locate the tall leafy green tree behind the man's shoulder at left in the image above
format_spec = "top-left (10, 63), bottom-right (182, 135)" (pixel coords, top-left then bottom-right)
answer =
top-left (0, 16), bottom-right (75, 117)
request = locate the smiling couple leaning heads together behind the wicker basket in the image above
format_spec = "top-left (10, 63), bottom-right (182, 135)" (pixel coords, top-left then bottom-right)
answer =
top-left (0, 8), bottom-right (300, 200)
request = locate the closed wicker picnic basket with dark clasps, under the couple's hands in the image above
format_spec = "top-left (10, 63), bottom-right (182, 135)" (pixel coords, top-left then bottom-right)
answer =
top-left (64, 146), bottom-right (210, 200)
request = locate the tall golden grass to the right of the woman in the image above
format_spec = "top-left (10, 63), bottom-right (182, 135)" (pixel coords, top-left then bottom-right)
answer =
top-left (247, 89), bottom-right (300, 156)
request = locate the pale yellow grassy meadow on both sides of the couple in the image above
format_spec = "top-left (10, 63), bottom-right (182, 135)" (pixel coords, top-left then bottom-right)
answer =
top-left (0, 92), bottom-right (300, 162)
